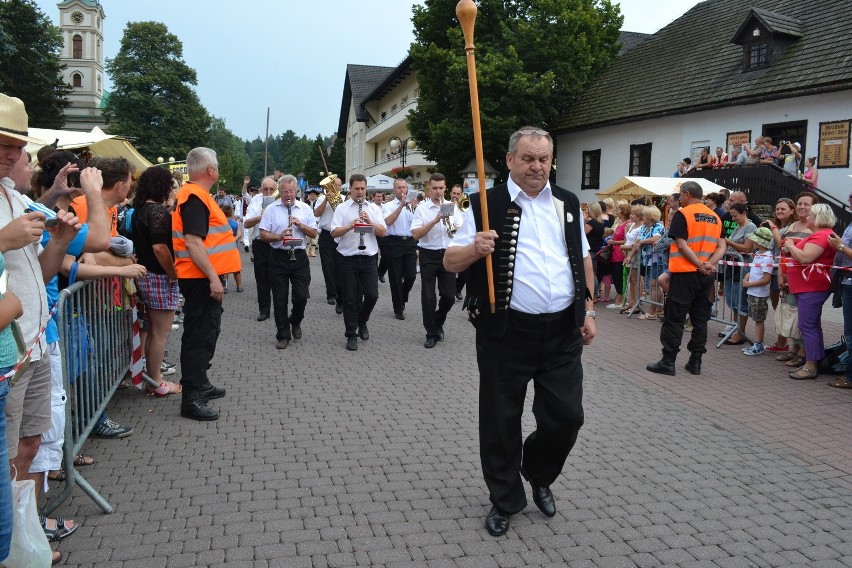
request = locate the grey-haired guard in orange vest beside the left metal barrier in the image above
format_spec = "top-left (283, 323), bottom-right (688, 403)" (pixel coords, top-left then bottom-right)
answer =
top-left (172, 148), bottom-right (240, 420)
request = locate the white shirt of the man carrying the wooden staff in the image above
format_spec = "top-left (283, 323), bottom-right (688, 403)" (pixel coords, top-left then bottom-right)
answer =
top-left (446, 176), bottom-right (589, 314)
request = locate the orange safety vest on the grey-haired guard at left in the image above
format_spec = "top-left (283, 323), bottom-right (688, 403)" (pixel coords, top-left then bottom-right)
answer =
top-left (172, 181), bottom-right (241, 278)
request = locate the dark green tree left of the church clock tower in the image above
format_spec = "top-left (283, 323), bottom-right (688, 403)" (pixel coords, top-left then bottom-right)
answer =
top-left (0, 0), bottom-right (71, 128)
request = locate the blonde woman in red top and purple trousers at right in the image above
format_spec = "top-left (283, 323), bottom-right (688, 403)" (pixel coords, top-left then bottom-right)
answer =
top-left (784, 203), bottom-right (837, 380)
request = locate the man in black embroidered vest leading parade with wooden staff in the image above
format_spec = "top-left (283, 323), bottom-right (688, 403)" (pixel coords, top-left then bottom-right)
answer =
top-left (444, 127), bottom-right (596, 536)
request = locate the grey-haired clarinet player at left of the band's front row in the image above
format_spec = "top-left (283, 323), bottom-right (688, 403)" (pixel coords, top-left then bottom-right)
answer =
top-left (259, 174), bottom-right (317, 349)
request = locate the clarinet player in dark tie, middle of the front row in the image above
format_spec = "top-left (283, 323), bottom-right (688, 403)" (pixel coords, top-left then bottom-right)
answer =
top-left (331, 174), bottom-right (387, 351)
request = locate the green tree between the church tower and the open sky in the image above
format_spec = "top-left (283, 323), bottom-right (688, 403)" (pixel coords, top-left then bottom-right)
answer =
top-left (104, 22), bottom-right (210, 159)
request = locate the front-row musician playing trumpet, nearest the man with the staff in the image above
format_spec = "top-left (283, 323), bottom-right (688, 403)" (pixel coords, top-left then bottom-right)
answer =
top-left (411, 173), bottom-right (463, 349)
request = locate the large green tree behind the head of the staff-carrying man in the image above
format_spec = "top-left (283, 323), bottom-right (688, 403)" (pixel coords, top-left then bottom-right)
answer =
top-left (409, 0), bottom-right (622, 181)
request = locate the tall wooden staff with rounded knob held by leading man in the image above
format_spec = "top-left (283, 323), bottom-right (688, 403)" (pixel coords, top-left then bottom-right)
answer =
top-left (456, 0), bottom-right (496, 314)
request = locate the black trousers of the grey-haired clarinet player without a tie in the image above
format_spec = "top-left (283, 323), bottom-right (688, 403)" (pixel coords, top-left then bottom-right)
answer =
top-left (269, 248), bottom-right (311, 341)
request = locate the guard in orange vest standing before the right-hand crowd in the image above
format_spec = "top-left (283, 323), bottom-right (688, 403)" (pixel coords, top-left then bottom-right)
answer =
top-left (647, 181), bottom-right (726, 375)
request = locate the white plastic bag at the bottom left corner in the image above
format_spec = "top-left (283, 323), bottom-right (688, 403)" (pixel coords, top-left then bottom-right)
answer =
top-left (3, 479), bottom-right (53, 568)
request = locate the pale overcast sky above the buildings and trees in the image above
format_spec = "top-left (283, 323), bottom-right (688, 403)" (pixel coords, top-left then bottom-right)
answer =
top-left (36, 0), bottom-right (697, 139)
